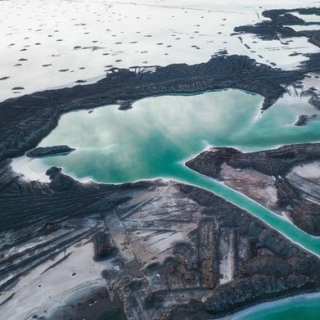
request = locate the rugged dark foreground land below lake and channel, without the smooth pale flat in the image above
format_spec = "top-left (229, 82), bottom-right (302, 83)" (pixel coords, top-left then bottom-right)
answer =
top-left (0, 168), bottom-right (320, 319)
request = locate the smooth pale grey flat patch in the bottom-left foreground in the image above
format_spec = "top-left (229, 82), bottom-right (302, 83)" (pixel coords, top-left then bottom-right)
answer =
top-left (0, 241), bottom-right (113, 319)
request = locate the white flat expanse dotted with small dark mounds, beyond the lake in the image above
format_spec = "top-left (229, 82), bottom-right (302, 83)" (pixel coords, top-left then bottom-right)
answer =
top-left (0, 0), bottom-right (319, 101)
